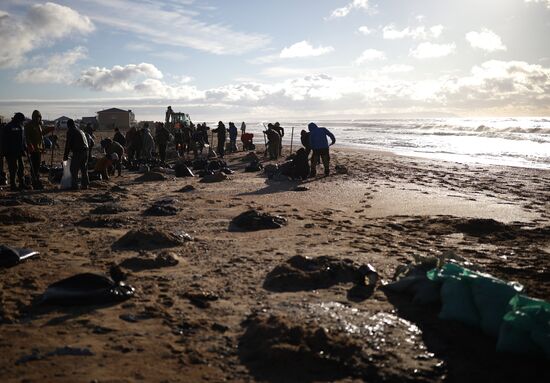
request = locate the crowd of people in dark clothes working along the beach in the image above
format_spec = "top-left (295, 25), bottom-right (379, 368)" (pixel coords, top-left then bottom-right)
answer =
top-left (0, 110), bottom-right (336, 191)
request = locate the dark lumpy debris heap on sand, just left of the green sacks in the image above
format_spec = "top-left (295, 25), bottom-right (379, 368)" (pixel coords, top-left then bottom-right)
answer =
top-left (264, 255), bottom-right (370, 291)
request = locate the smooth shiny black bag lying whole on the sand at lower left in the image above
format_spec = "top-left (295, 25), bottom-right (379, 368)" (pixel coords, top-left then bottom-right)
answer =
top-left (42, 273), bottom-right (134, 305)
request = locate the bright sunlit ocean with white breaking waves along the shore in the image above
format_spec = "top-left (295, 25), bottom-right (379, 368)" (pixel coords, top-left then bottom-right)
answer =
top-left (237, 117), bottom-right (550, 169)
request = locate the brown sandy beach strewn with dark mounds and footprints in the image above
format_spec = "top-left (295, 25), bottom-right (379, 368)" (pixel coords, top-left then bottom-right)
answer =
top-left (0, 147), bottom-right (550, 382)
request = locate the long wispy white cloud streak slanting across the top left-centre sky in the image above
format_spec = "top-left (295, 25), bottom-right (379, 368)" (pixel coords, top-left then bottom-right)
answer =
top-left (80, 0), bottom-right (270, 55)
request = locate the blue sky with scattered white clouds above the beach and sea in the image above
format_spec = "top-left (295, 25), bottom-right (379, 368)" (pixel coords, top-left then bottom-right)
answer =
top-left (0, 0), bottom-right (550, 120)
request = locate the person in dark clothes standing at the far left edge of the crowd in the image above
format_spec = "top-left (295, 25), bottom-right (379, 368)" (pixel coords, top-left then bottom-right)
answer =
top-left (0, 113), bottom-right (27, 191)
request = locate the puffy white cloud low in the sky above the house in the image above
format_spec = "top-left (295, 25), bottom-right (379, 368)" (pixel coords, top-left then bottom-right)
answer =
top-left (76, 63), bottom-right (163, 92)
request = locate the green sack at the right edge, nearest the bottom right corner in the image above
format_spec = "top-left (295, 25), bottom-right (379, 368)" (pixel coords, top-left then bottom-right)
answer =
top-left (497, 294), bottom-right (550, 359)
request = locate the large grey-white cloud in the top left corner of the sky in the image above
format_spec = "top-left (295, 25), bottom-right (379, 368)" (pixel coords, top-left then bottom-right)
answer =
top-left (0, 3), bottom-right (94, 68)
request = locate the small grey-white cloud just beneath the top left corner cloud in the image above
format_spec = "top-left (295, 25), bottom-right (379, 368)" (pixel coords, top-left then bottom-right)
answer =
top-left (15, 47), bottom-right (87, 83)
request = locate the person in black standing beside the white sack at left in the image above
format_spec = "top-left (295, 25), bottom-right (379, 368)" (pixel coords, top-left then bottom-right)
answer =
top-left (63, 119), bottom-right (89, 190)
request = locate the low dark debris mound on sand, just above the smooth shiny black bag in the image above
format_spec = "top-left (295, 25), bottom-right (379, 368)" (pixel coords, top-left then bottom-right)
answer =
top-left (112, 228), bottom-right (192, 250)
